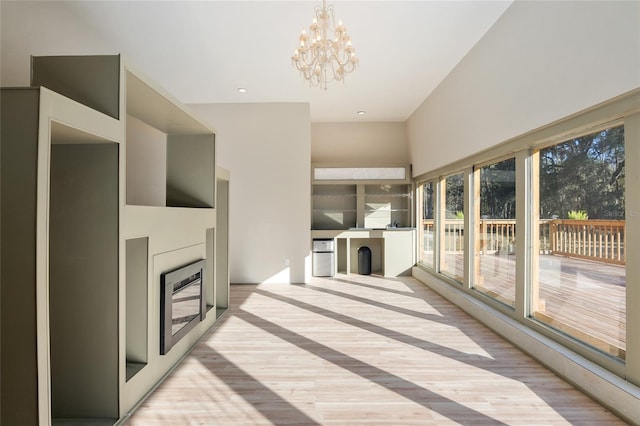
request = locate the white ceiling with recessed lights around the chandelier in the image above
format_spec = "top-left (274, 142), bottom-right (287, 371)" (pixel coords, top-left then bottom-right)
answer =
top-left (0, 0), bottom-right (511, 122)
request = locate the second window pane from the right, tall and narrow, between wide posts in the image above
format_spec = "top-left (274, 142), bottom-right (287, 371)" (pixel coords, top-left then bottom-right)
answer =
top-left (474, 158), bottom-right (516, 306)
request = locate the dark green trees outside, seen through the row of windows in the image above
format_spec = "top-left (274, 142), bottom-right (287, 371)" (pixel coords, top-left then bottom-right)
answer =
top-left (436, 126), bottom-right (625, 219)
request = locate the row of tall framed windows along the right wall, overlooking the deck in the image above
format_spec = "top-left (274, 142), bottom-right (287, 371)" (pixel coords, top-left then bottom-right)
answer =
top-left (416, 90), bottom-right (640, 383)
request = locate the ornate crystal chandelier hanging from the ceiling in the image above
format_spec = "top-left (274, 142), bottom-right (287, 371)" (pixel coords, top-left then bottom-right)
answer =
top-left (291, 0), bottom-right (358, 90)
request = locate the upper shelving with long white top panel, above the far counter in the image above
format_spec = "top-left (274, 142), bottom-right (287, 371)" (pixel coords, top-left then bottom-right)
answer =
top-left (311, 165), bottom-right (413, 230)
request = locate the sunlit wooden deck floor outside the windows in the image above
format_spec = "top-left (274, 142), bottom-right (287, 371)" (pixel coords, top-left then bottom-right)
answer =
top-left (436, 254), bottom-right (626, 359)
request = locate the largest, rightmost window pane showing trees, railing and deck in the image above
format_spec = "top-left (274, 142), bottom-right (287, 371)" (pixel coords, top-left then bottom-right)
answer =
top-left (532, 126), bottom-right (626, 359)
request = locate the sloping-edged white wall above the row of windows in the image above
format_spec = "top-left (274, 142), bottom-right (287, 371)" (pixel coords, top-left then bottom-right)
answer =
top-left (407, 1), bottom-right (640, 176)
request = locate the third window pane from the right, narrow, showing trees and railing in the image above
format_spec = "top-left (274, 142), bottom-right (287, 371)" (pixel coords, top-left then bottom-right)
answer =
top-left (440, 173), bottom-right (464, 281)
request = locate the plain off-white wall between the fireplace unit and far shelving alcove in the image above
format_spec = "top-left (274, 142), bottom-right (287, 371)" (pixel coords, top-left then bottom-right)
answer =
top-left (190, 103), bottom-right (311, 283)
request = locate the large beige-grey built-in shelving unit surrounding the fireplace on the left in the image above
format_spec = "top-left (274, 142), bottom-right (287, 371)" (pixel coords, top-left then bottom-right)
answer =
top-left (0, 55), bottom-right (229, 425)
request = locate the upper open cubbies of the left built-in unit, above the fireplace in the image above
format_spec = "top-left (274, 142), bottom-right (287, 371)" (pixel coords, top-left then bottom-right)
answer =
top-left (31, 55), bottom-right (216, 208)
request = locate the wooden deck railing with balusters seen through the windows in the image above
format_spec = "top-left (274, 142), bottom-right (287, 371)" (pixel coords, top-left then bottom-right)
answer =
top-left (423, 219), bottom-right (626, 265)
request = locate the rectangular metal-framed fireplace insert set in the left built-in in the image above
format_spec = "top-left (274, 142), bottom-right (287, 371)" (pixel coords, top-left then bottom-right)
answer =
top-left (160, 259), bottom-right (206, 355)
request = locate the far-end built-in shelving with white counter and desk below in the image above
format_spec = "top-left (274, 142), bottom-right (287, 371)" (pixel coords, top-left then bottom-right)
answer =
top-left (311, 164), bottom-right (415, 276)
